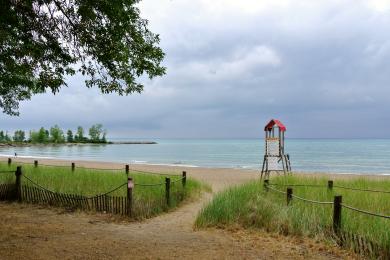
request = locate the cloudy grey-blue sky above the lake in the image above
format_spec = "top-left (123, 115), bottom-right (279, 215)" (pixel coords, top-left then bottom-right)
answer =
top-left (0, 0), bottom-right (390, 139)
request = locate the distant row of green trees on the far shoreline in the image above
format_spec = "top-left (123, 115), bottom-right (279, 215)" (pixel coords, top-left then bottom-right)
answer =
top-left (0, 124), bottom-right (107, 144)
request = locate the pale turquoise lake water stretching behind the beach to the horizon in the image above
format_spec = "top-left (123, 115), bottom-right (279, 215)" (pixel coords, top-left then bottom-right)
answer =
top-left (0, 139), bottom-right (390, 174)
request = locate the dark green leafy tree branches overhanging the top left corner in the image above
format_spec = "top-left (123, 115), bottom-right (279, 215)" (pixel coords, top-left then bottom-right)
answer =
top-left (0, 0), bottom-right (165, 115)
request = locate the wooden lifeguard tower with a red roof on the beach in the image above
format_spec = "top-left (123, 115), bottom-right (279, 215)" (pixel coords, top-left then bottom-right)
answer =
top-left (261, 119), bottom-right (291, 178)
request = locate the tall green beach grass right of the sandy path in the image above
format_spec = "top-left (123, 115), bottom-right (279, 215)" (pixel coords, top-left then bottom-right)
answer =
top-left (195, 176), bottom-right (390, 256)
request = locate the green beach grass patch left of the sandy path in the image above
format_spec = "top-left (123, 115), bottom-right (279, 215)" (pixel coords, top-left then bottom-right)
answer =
top-left (0, 163), bottom-right (204, 218)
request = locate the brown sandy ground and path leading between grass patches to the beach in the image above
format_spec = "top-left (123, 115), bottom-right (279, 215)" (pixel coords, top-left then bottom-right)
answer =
top-left (0, 159), bottom-right (351, 259)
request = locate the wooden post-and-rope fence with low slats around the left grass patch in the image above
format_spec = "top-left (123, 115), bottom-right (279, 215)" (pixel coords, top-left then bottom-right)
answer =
top-left (0, 159), bottom-right (187, 218)
